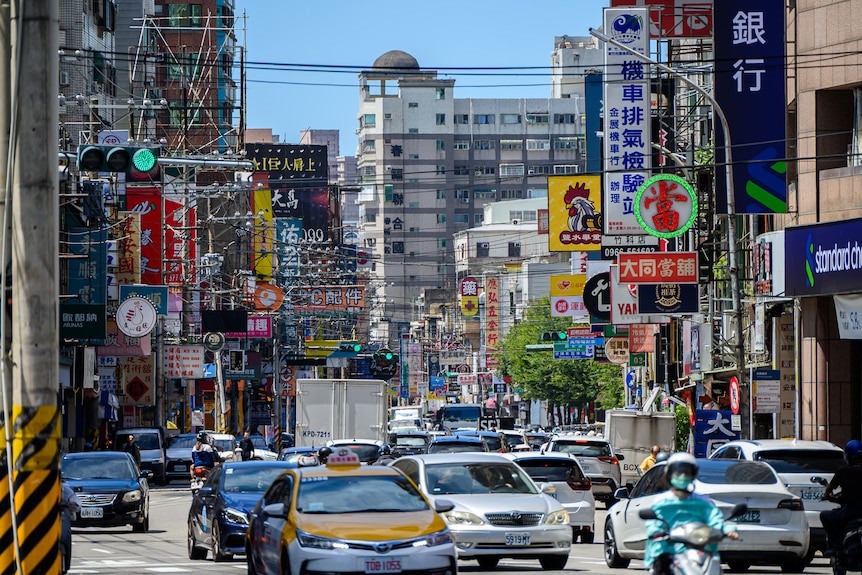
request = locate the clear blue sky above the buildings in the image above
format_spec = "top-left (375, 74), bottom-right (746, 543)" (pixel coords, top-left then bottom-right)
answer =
top-left (236, 0), bottom-right (610, 156)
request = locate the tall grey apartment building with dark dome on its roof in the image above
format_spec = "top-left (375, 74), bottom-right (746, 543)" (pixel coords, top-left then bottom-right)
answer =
top-left (357, 45), bottom-right (598, 342)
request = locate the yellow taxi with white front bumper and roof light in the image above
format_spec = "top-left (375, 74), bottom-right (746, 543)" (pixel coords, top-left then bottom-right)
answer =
top-left (246, 447), bottom-right (458, 575)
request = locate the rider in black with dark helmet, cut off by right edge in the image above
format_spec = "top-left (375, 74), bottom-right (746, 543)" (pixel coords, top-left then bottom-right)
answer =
top-left (820, 439), bottom-right (862, 556)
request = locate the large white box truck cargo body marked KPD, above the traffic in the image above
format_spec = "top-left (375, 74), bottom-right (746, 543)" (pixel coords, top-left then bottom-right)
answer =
top-left (295, 379), bottom-right (389, 447)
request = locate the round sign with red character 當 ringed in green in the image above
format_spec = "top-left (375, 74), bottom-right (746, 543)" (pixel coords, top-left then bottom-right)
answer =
top-left (635, 174), bottom-right (697, 238)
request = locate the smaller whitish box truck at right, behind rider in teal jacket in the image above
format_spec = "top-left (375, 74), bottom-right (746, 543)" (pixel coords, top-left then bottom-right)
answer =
top-left (604, 409), bottom-right (676, 486)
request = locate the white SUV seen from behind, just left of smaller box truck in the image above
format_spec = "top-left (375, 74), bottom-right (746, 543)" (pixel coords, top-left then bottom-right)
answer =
top-left (541, 435), bottom-right (623, 507)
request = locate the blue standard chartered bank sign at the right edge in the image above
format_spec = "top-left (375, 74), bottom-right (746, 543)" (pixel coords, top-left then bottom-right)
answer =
top-left (784, 219), bottom-right (862, 296)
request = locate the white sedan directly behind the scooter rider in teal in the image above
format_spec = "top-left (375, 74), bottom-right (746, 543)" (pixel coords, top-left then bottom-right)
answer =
top-left (604, 459), bottom-right (809, 573)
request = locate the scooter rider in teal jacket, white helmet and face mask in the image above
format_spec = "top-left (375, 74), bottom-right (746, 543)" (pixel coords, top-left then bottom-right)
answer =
top-left (644, 453), bottom-right (739, 575)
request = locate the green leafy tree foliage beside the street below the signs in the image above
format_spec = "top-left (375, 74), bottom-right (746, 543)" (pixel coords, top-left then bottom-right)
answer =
top-left (497, 297), bottom-right (623, 418)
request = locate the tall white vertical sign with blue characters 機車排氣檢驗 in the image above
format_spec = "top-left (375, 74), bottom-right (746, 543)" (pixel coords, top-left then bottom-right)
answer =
top-left (602, 8), bottom-right (652, 235)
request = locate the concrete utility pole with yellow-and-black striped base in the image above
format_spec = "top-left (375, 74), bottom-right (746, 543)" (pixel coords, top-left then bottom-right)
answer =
top-left (5, 0), bottom-right (60, 574)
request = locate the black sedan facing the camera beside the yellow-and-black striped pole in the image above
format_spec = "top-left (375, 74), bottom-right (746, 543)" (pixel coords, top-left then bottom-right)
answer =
top-left (61, 451), bottom-right (153, 533)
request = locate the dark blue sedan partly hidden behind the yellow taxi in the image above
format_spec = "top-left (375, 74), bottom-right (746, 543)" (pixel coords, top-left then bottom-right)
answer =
top-left (188, 460), bottom-right (296, 561)
